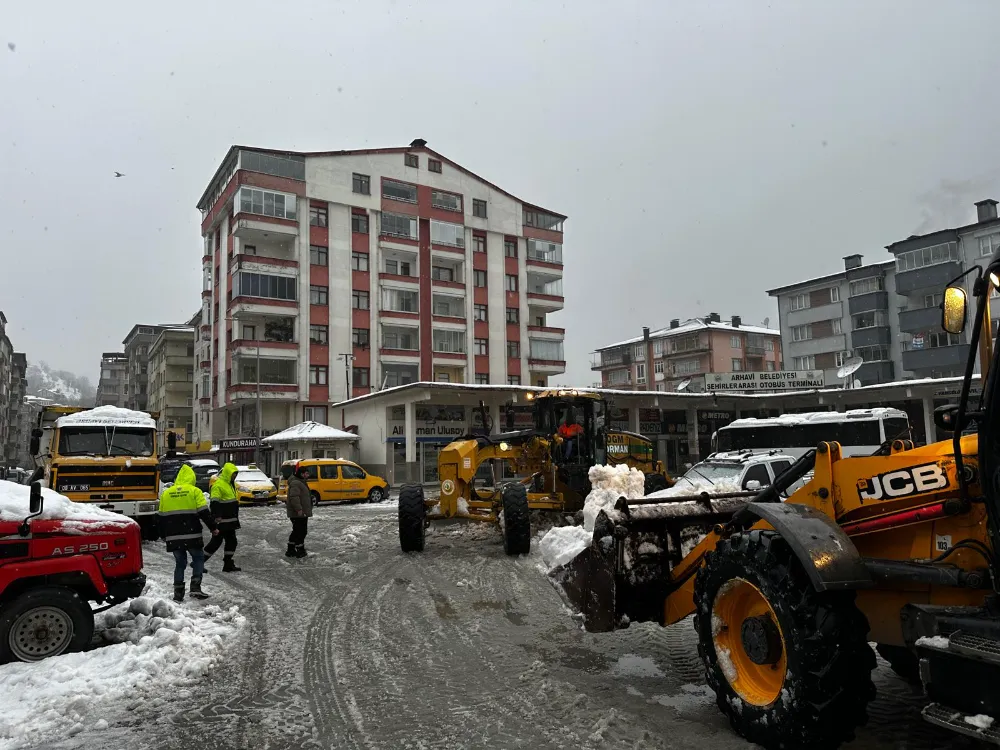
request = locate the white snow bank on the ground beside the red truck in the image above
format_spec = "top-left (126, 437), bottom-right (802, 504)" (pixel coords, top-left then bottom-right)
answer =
top-left (0, 597), bottom-right (244, 749)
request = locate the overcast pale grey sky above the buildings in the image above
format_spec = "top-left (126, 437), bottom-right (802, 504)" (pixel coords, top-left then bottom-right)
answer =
top-left (0, 0), bottom-right (1000, 384)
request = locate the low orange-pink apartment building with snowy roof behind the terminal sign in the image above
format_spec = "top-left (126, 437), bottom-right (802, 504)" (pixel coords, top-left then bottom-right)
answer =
top-left (591, 313), bottom-right (782, 391)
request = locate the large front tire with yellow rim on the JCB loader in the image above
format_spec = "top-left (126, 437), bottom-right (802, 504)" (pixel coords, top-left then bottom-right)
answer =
top-left (694, 530), bottom-right (875, 750)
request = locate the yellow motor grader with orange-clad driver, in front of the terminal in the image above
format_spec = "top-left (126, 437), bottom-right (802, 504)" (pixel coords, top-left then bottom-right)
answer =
top-left (399, 389), bottom-right (673, 555)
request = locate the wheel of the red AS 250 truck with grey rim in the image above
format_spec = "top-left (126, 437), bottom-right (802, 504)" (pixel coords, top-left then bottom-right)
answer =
top-left (0, 586), bottom-right (94, 662)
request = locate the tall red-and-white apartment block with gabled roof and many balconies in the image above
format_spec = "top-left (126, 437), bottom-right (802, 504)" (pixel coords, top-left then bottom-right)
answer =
top-left (196, 140), bottom-right (565, 440)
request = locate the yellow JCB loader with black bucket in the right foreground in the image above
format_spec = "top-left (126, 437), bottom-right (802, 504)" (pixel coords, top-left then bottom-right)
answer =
top-left (553, 262), bottom-right (1000, 748)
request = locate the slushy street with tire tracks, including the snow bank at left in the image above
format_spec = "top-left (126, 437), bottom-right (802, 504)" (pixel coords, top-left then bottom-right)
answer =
top-left (9, 503), bottom-right (975, 750)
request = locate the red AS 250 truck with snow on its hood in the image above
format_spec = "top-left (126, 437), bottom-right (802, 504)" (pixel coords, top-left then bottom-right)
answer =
top-left (0, 482), bottom-right (146, 663)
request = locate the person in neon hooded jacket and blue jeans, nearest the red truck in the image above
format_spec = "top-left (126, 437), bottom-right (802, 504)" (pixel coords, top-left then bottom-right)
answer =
top-left (157, 464), bottom-right (219, 602)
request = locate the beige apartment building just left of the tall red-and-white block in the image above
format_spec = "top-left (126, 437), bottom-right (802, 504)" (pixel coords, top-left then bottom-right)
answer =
top-left (148, 327), bottom-right (195, 445)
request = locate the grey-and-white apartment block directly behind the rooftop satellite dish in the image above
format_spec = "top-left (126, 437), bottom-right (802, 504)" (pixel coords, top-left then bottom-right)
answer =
top-left (768, 255), bottom-right (904, 387)
